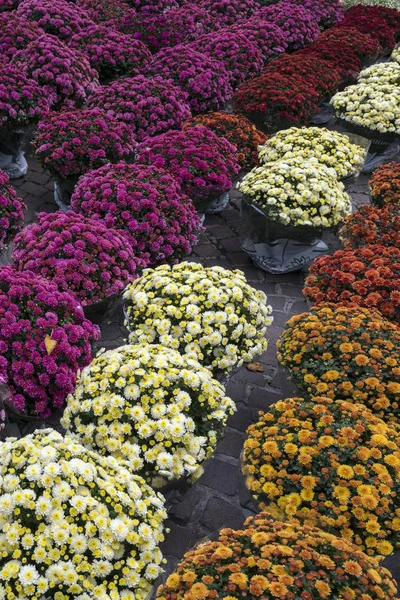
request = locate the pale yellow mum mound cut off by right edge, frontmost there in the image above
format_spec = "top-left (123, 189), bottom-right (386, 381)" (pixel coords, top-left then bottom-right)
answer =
top-left (331, 81), bottom-right (400, 133)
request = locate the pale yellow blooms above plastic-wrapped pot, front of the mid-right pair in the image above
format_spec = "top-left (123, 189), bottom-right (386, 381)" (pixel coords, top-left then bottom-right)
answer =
top-left (238, 158), bottom-right (351, 228)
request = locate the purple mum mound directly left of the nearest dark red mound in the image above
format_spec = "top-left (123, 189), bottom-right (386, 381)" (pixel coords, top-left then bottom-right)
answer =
top-left (148, 45), bottom-right (233, 113)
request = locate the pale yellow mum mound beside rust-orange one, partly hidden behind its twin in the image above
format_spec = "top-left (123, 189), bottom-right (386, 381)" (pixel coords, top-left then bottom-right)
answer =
top-left (258, 127), bottom-right (367, 178)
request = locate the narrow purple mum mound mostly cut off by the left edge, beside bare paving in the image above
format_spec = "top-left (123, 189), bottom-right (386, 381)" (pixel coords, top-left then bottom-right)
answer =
top-left (0, 170), bottom-right (26, 250)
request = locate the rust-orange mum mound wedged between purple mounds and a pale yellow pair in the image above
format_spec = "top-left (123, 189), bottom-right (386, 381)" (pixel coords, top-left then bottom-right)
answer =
top-left (184, 111), bottom-right (267, 169)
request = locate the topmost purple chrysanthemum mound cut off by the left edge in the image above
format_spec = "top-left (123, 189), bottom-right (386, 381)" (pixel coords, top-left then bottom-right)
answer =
top-left (0, 11), bottom-right (44, 60)
